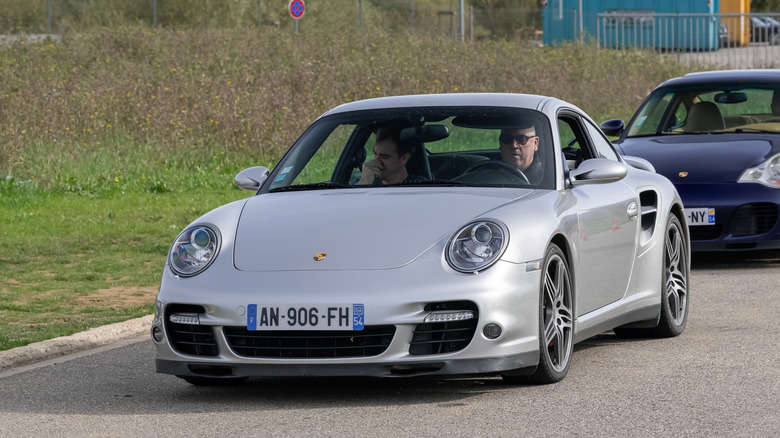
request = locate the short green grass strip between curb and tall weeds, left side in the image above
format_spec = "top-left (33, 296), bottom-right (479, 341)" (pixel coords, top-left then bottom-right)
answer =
top-left (0, 173), bottom-right (246, 349)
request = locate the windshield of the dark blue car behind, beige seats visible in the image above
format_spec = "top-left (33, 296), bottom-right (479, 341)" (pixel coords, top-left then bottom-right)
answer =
top-left (627, 85), bottom-right (780, 137)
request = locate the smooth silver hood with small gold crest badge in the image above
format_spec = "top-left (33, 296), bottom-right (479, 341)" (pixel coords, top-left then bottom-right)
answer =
top-left (234, 188), bottom-right (532, 271)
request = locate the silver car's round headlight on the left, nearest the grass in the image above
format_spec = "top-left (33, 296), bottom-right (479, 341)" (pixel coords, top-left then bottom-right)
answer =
top-left (168, 225), bottom-right (219, 277)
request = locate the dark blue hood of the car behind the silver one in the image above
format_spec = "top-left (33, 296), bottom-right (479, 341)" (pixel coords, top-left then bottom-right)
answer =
top-left (619, 134), bottom-right (772, 184)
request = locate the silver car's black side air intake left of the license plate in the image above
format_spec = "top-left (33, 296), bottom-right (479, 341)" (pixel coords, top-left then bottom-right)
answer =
top-left (165, 304), bottom-right (219, 356)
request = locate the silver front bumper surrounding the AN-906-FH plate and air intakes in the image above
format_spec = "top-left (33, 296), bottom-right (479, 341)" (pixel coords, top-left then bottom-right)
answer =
top-left (152, 260), bottom-right (541, 378)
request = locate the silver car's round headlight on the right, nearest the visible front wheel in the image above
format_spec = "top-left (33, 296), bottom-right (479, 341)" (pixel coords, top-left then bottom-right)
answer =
top-left (447, 221), bottom-right (509, 272)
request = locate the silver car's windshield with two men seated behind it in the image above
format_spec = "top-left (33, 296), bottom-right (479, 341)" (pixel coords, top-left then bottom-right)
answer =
top-left (264, 107), bottom-right (555, 192)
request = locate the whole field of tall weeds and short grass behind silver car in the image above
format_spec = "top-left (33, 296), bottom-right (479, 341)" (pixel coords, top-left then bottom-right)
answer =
top-left (0, 6), bottom-right (687, 349)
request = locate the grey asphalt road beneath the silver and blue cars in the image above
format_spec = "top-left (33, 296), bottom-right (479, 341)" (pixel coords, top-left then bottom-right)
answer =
top-left (0, 252), bottom-right (780, 437)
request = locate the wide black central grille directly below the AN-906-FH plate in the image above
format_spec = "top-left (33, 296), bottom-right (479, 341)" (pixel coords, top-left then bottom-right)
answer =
top-left (223, 325), bottom-right (395, 359)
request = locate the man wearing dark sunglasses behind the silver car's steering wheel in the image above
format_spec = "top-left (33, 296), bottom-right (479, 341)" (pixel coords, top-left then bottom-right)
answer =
top-left (498, 122), bottom-right (542, 184)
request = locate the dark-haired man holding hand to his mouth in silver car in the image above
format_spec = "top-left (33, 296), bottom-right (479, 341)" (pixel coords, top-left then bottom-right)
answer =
top-left (357, 128), bottom-right (424, 185)
